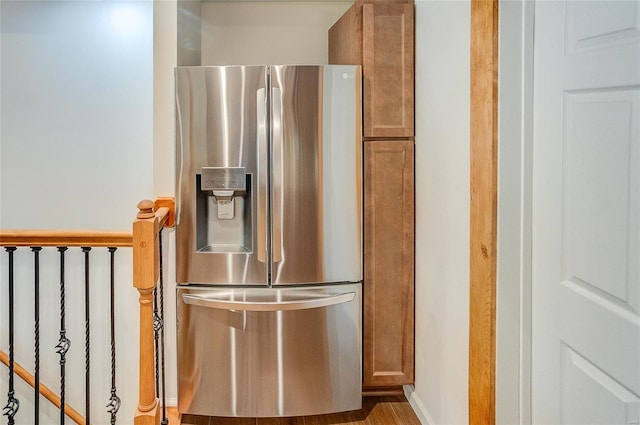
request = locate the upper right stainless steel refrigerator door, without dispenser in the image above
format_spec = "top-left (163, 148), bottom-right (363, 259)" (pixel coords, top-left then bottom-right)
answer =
top-left (271, 65), bottom-right (362, 285)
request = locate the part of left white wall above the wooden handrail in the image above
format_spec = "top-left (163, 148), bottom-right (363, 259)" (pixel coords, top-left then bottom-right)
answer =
top-left (0, 1), bottom-right (152, 230)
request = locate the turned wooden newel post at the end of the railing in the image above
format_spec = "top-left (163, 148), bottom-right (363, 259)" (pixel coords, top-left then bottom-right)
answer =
top-left (133, 200), bottom-right (161, 425)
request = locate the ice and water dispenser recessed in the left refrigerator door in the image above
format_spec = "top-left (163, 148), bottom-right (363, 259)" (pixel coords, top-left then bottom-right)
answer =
top-left (196, 167), bottom-right (252, 252)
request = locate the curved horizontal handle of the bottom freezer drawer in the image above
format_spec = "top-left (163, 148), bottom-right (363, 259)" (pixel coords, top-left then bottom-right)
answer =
top-left (182, 292), bottom-right (356, 311)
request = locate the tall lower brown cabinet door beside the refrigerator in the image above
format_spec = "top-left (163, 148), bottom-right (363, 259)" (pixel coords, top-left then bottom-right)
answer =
top-left (364, 141), bottom-right (414, 386)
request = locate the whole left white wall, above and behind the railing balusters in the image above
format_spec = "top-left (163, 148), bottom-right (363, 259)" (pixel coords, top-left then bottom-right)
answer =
top-left (0, 1), bottom-right (153, 424)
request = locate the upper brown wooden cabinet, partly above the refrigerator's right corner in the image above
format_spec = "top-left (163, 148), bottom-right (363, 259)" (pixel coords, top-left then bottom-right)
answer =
top-left (329, 2), bottom-right (414, 138)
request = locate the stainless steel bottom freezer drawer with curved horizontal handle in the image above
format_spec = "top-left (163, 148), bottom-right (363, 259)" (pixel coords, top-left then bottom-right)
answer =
top-left (177, 283), bottom-right (362, 417)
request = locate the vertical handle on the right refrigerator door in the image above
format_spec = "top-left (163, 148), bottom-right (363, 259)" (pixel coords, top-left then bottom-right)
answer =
top-left (271, 85), bottom-right (284, 263)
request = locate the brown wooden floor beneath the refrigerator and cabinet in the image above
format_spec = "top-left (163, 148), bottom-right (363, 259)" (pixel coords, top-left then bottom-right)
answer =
top-left (181, 396), bottom-right (420, 425)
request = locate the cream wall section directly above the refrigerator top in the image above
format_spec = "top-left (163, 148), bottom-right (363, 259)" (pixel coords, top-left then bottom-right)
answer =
top-left (201, 1), bottom-right (353, 65)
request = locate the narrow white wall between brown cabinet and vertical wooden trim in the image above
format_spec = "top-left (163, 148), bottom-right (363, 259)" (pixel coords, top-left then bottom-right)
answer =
top-left (410, 0), bottom-right (470, 424)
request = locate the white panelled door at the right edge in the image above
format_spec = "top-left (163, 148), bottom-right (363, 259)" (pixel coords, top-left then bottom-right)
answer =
top-left (531, 0), bottom-right (640, 425)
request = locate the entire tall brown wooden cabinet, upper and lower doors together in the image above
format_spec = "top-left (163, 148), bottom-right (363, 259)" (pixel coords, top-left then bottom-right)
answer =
top-left (329, 0), bottom-right (415, 392)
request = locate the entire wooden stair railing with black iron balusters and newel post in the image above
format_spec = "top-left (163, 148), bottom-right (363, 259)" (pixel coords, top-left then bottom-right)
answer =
top-left (0, 198), bottom-right (174, 425)
